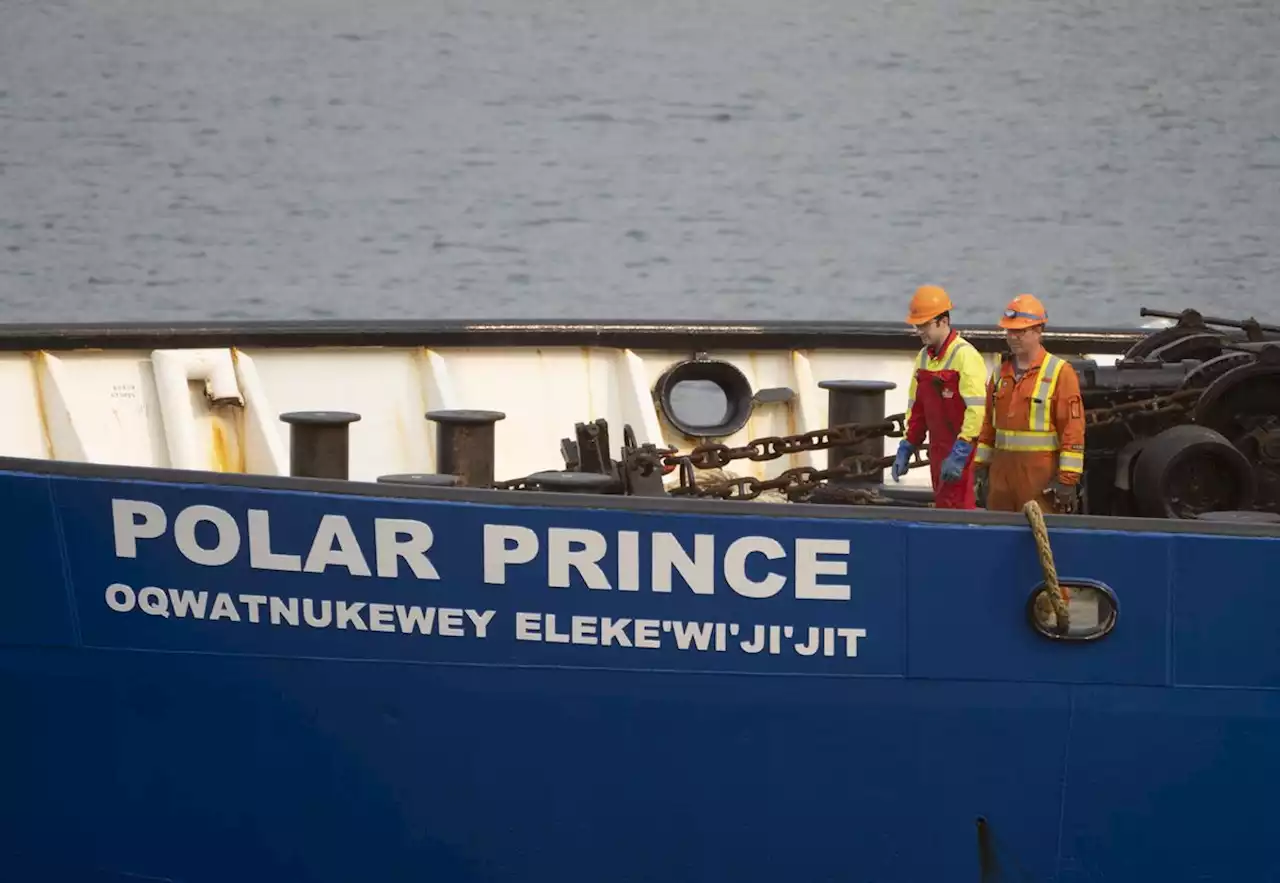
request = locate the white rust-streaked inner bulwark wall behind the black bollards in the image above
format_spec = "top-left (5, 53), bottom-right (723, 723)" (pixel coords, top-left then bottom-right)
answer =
top-left (0, 335), bottom-right (1131, 486)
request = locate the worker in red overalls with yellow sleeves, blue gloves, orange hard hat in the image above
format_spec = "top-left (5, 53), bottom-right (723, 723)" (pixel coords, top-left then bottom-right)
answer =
top-left (891, 285), bottom-right (987, 509)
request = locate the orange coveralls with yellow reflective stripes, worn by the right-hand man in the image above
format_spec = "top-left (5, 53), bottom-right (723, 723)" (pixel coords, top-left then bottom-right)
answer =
top-left (974, 352), bottom-right (1084, 512)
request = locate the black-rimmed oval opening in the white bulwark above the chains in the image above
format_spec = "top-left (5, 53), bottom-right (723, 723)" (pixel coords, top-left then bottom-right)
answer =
top-left (653, 358), bottom-right (751, 439)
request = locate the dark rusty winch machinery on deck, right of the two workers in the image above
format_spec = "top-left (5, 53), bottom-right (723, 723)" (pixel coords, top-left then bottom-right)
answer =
top-left (1073, 307), bottom-right (1280, 518)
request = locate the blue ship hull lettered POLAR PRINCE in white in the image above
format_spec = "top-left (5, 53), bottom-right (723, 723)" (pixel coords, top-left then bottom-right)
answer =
top-left (0, 461), bottom-right (1280, 883)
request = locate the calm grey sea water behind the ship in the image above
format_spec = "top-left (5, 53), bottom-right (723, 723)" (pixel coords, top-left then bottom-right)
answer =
top-left (0, 0), bottom-right (1280, 324)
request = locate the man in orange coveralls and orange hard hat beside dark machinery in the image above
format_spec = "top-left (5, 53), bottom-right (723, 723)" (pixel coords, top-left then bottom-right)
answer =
top-left (977, 294), bottom-right (1084, 512)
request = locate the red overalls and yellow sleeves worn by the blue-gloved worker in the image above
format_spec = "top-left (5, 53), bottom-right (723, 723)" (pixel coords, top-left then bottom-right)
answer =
top-left (906, 330), bottom-right (987, 509)
